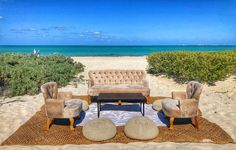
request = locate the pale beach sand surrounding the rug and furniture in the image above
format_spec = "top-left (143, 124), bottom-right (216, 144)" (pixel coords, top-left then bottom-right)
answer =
top-left (0, 56), bottom-right (236, 149)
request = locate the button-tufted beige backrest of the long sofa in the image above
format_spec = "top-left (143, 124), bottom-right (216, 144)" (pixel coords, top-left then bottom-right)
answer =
top-left (89, 70), bottom-right (145, 85)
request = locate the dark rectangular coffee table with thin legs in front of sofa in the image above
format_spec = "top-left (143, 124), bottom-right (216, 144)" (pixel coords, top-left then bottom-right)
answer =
top-left (97, 93), bottom-right (147, 118)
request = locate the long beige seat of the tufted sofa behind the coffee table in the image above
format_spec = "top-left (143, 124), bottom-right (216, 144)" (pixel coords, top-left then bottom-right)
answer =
top-left (88, 84), bottom-right (150, 96)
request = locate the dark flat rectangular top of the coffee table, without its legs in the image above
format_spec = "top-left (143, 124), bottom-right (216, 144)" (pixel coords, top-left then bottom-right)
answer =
top-left (97, 93), bottom-right (146, 101)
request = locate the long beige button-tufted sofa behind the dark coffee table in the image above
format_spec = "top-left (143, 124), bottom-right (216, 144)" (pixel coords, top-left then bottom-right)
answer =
top-left (88, 70), bottom-right (150, 102)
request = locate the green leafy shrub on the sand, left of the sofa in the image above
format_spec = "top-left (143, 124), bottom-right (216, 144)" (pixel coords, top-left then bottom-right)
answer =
top-left (0, 53), bottom-right (84, 96)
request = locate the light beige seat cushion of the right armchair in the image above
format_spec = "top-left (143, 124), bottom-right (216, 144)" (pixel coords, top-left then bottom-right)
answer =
top-left (162, 98), bottom-right (181, 118)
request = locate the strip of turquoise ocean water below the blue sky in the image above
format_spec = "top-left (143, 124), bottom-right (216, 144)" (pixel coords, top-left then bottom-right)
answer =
top-left (0, 45), bottom-right (236, 56)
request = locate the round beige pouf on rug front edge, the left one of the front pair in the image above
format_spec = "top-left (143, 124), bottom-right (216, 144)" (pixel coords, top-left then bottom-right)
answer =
top-left (82, 118), bottom-right (116, 141)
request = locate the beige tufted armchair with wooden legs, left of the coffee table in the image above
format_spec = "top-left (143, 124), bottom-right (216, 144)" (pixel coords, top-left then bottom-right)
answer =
top-left (41, 82), bottom-right (82, 130)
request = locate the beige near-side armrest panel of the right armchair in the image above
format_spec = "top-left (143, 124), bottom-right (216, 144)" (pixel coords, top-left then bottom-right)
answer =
top-left (179, 99), bottom-right (198, 117)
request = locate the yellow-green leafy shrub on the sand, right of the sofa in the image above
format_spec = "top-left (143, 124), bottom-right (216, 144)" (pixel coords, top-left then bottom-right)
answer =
top-left (147, 51), bottom-right (236, 84)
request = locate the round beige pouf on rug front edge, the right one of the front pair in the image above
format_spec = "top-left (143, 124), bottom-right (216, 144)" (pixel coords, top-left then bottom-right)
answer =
top-left (124, 116), bottom-right (159, 140)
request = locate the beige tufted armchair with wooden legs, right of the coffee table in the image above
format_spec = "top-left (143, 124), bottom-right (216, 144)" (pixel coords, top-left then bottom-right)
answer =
top-left (162, 81), bottom-right (202, 129)
